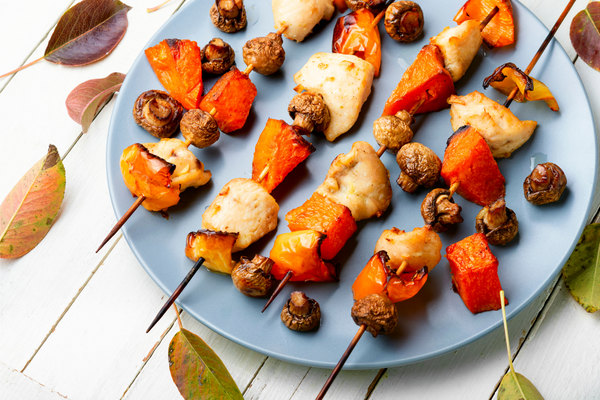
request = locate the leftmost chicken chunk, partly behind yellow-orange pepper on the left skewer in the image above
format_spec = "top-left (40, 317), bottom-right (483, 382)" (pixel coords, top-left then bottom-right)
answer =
top-left (144, 139), bottom-right (212, 192)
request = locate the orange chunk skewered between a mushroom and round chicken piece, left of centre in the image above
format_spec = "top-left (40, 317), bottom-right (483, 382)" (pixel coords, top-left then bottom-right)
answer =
top-left (252, 118), bottom-right (316, 193)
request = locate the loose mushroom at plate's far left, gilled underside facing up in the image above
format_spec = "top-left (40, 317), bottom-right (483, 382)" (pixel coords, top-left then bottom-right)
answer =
top-left (133, 90), bottom-right (183, 139)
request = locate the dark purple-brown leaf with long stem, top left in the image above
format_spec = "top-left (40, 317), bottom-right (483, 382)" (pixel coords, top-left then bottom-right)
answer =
top-left (0, 0), bottom-right (131, 78)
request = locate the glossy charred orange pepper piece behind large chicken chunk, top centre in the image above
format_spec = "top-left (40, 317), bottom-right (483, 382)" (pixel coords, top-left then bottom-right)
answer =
top-left (332, 8), bottom-right (381, 76)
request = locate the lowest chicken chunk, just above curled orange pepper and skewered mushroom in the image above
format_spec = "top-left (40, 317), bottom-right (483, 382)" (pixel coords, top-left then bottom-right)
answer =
top-left (375, 225), bottom-right (442, 271)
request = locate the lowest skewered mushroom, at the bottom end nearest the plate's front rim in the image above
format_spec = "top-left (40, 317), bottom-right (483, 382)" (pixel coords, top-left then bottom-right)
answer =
top-left (351, 293), bottom-right (398, 337)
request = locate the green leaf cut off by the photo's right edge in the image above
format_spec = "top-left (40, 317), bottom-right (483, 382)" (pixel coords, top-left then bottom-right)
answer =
top-left (562, 224), bottom-right (600, 313)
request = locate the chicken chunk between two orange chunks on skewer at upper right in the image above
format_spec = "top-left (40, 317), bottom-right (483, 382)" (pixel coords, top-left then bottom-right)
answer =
top-left (430, 20), bottom-right (483, 82)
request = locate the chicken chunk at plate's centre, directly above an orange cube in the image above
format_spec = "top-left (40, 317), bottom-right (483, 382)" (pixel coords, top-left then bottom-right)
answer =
top-left (316, 142), bottom-right (392, 221)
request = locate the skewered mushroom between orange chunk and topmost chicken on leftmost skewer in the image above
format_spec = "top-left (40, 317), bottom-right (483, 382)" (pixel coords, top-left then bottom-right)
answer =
top-left (242, 33), bottom-right (285, 75)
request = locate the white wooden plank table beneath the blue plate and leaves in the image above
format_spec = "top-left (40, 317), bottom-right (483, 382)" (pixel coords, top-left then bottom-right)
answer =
top-left (0, 0), bottom-right (600, 400)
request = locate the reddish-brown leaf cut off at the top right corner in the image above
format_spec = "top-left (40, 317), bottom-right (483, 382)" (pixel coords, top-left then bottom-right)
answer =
top-left (570, 1), bottom-right (600, 71)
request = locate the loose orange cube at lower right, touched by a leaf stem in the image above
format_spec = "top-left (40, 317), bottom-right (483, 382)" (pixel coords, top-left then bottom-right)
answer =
top-left (446, 233), bottom-right (508, 314)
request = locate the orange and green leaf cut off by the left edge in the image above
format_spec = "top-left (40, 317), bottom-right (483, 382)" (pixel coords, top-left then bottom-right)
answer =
top-left (0, 145), bottom-right (66, 258)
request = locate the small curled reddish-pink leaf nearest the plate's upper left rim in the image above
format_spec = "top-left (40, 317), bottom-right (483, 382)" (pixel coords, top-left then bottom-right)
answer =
top-left (66, 72), bottom-right (125, 133)
